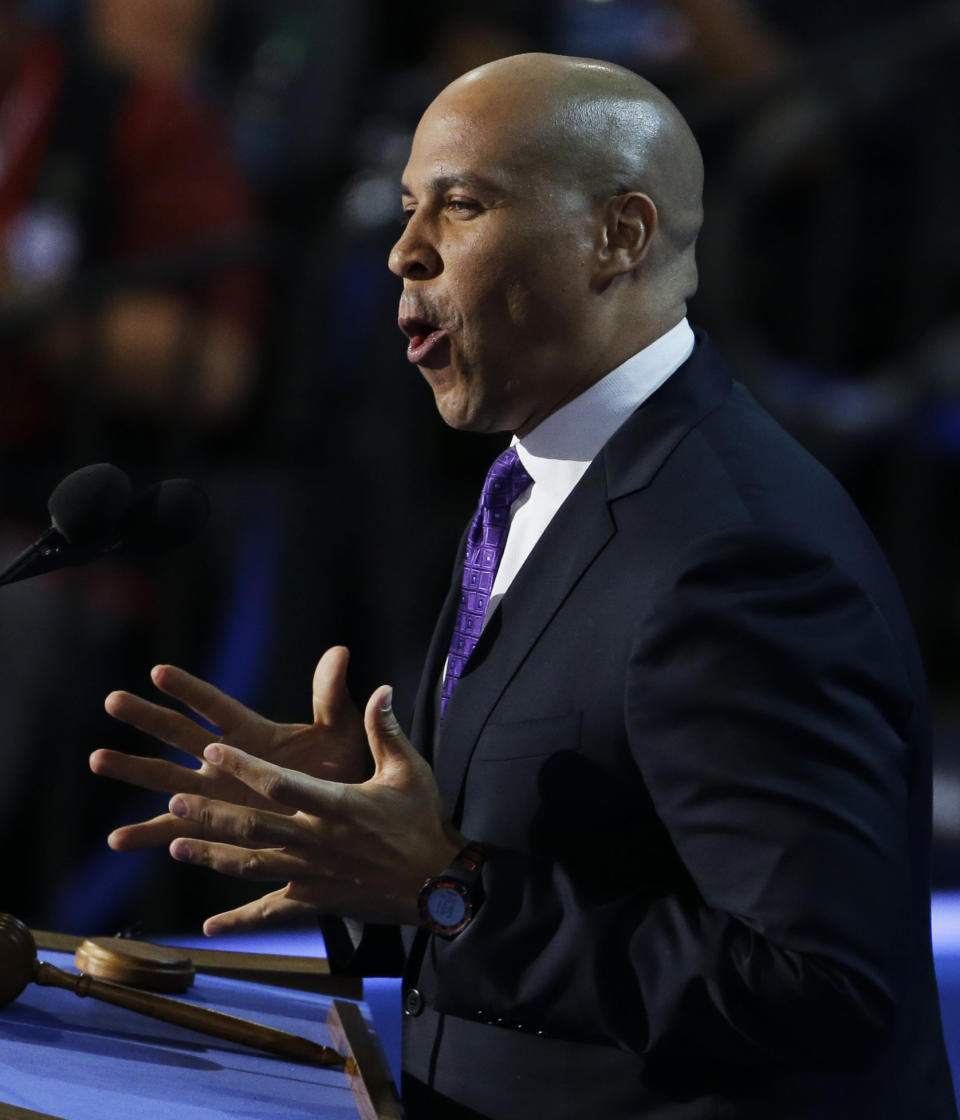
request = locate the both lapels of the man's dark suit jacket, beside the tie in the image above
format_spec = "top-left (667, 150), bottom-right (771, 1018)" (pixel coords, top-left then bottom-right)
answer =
top-left (413, 338), bottom-right (730, 820)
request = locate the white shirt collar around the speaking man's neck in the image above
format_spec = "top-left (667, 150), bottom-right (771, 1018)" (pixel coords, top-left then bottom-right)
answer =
top-left (513, 319), bottom-right (695, 486)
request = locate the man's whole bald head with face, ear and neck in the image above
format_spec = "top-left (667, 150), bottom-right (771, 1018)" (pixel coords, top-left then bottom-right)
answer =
top-left (390, 55), bottom-right (702, 436)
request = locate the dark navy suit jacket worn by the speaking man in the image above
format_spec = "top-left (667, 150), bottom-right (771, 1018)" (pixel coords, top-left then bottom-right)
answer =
top-left (349, 338), bottom-right (957, 1120)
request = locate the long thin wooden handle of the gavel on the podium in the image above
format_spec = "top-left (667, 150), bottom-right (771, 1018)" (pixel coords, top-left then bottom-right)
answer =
top-left (34, 962), bottom-right (345, 1065)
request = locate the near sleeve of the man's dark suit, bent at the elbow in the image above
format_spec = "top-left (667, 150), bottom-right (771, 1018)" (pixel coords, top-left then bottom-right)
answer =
top-left (425, 532), bottom-right (915, 1070)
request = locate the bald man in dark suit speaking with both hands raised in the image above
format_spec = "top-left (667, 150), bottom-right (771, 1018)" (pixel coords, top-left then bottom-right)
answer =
top-left (92, 55), bottom-right (956, 1120)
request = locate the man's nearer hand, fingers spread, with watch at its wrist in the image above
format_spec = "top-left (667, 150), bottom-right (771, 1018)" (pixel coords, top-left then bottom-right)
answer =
top-left (160, 688), bottom-right (466, 934)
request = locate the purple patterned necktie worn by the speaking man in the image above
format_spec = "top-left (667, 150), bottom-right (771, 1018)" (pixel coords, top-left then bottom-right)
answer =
top-left (440, 447), bottom-right (533, 718)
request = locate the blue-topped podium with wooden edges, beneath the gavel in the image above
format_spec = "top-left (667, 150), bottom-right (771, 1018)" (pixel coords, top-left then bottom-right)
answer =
top-left (0, 931), bottom-right (402, 1120)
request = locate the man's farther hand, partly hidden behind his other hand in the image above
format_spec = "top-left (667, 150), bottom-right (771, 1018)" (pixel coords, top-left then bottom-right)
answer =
top-left (90, 646), bottom-right (373, 851)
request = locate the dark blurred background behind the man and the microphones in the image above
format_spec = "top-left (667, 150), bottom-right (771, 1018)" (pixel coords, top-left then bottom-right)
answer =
top-left (0, 0), bottom-right (960, 954)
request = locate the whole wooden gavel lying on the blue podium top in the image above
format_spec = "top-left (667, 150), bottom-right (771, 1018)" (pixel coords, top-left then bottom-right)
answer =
top-left (0, 914), bottom-right (346, 1066)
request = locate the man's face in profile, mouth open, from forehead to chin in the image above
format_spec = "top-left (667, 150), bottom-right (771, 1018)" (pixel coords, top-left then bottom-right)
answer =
top-left (390, 91), bottom-right (596, 435)
